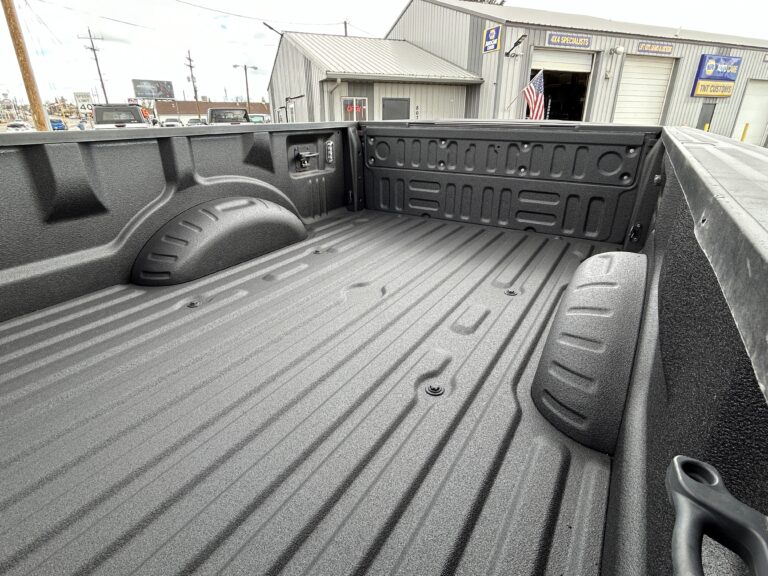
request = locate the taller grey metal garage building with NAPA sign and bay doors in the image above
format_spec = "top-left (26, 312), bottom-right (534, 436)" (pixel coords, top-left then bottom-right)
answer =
top-left (386, 0), bottom-right (768, 145)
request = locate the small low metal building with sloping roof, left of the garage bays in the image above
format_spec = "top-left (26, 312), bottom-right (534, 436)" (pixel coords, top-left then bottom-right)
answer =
top-left (269, 32), bottom-right (482, 122)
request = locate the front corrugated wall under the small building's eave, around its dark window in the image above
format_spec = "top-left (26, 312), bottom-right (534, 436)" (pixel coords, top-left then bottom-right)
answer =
top-left (373, 82), bottom-right (466, 120)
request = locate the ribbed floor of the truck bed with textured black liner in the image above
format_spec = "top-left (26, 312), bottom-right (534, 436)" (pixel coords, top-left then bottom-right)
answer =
top-left (0, 211), bottom-right (610, 575)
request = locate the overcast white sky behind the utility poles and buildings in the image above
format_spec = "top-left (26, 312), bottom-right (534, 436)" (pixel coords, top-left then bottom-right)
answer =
top-left (0, 0), bottom-right (768, 102)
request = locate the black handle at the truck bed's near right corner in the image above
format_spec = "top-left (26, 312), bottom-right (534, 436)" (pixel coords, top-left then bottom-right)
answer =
top-left (666, 456), bottom-right (768, 576)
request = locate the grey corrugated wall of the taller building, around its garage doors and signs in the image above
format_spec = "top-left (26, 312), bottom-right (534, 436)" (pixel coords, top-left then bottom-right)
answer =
top-left (388, 0), bottom-right (768, 136)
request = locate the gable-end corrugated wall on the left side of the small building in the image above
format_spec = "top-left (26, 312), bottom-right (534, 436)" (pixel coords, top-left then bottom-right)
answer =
top-left (269, 38), bottom-right (324, 122)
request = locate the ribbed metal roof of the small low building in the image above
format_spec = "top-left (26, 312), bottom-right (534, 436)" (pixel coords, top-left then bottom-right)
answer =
top-left (283, 32), bottom-right (483, 84)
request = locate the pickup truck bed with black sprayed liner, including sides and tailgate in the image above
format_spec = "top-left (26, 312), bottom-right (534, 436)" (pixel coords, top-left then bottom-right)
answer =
top-left (0, 122), bottom-right (768, 576)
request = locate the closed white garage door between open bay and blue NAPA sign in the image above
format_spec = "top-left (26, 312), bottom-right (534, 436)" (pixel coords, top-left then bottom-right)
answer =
top-left (613, 56), bottom-right (675, 125)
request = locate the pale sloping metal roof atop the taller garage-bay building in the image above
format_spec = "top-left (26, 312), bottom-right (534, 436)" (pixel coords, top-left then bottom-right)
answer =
top-left (427, 0), bottom-right (768, 48)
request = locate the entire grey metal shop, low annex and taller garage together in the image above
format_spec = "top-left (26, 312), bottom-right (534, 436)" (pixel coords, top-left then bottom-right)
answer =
top-left (270, 0), bottom-right (768, 145)
